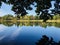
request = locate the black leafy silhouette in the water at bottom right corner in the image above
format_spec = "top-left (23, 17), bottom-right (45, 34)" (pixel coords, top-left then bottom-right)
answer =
top-left (36, 35), bottom-right (60, 45)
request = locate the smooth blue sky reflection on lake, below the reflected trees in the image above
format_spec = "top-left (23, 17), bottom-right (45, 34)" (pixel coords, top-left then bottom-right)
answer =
top-left (0, 24), bottom-right (60, 45)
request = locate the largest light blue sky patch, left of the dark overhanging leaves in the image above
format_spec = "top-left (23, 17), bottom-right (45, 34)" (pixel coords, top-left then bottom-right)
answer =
top-left (0, 3), bottom-right (14, 16)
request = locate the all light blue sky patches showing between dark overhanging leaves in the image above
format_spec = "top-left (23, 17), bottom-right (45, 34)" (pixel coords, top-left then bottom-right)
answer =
top-left (0, 1), bottom-right (55, 16)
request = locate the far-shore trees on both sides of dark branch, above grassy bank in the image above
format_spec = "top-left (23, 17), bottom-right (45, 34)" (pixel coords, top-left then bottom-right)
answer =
top-left (0, 14), bottom-right (60, 20)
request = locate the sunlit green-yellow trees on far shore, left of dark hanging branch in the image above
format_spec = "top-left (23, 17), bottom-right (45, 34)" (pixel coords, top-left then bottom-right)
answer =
top-left (0, 14), bottom-right (40, 20)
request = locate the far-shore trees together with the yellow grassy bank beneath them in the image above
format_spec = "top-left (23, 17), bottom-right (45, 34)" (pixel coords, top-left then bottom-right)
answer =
top-left (0, 14), bottom-right (60, 22)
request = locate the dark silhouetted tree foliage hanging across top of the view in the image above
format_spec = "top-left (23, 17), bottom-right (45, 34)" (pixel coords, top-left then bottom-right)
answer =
top-left (0, 0), bottom-right (60, 20)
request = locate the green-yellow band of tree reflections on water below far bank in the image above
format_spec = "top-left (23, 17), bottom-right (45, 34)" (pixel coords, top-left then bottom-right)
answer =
top-left (0, 21), bottom-right (60, 28)
